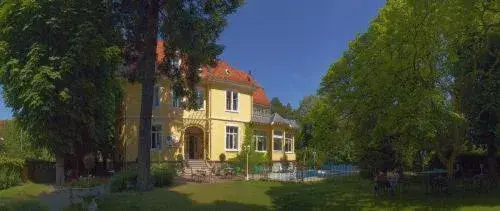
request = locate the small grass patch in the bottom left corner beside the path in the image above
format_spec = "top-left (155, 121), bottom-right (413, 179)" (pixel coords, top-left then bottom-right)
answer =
top-left (0, 183), bottom-right (50, 210)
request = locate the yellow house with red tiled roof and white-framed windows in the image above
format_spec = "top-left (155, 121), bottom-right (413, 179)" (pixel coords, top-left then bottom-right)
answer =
top-left (122, 45), bottom-right (297, 161)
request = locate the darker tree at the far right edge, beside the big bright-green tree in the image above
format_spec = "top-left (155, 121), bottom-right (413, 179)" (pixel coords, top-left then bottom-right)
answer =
top-left (452, 1), bottom-right (500, 181)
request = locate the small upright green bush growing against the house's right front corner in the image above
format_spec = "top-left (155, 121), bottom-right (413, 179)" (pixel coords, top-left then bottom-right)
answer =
top-left (228, 123), bottom-right (267, 172)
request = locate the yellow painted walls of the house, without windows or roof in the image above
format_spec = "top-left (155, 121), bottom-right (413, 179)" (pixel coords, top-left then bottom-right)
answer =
top-left (124, 80), bottom-right (295, 161)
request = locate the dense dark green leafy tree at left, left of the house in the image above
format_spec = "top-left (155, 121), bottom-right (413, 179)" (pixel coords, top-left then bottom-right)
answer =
top-left (0, 0), bottom-right (122, 184)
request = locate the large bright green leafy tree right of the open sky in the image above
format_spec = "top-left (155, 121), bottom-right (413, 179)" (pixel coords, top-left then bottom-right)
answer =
top-left (315, 0), bottom-right (498, 173)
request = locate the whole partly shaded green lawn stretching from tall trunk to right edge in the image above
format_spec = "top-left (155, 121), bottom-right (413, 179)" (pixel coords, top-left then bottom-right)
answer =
top-left (100, 178), bottom-right (500, 210)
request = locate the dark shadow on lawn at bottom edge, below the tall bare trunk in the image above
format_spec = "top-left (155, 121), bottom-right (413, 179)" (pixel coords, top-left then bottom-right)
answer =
top-left (98, 188), bottom-right (269, 210)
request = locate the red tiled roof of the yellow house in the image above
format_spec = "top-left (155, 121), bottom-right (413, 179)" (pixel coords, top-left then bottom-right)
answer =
top-left (156, 40), bottom-right (271, 106)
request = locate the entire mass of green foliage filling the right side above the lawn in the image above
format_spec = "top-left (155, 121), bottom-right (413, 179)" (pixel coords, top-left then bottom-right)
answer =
top-left (309, 0), bottom-right (500, 176)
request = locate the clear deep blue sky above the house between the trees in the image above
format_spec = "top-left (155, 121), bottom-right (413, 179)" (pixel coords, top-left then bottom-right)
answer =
top-left (0, 0), bottom-right (385, 119)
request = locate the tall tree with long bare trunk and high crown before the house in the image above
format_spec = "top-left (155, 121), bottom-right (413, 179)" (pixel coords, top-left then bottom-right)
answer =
top-left (119, 0), bottom-right (242, 190)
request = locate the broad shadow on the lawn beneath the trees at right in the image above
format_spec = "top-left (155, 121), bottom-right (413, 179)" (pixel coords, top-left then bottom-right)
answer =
top-left (267, 177), bottom-right (500, 210)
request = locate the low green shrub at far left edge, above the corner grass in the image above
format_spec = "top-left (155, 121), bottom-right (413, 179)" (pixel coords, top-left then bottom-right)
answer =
top-left (0, 157), bottom-right (25, 190)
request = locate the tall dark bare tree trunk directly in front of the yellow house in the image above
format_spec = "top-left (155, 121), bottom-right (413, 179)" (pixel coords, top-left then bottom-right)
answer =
top-left (137, 0), bottom-right (159, 191)
